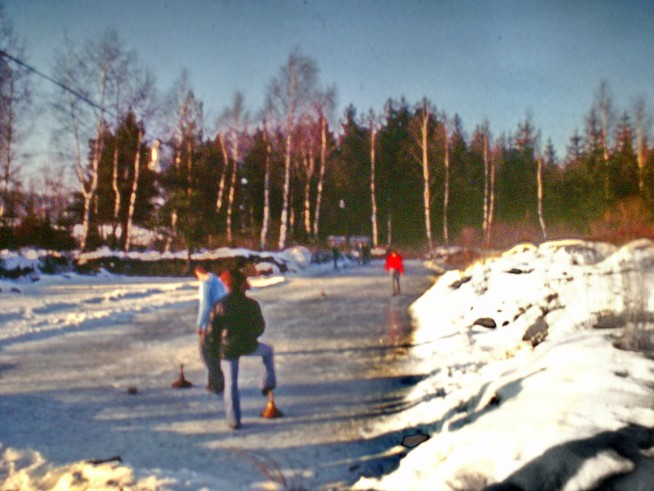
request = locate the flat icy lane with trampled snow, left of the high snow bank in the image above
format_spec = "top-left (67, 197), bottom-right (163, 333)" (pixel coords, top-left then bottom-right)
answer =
top-left (0, 252), bottom-right (432, 490)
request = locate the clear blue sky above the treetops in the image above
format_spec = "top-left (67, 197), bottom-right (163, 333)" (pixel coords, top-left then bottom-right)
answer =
top-left (5, 0), bottom-right (654, 177)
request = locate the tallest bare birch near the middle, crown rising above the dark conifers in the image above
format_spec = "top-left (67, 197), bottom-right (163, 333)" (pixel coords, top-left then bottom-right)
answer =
top-left (267, 49), bottom-right (318, 249)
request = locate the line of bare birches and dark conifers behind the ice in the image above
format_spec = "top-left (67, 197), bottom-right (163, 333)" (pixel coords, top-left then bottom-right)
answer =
top-left (0, 19), bottom-right (654, 251)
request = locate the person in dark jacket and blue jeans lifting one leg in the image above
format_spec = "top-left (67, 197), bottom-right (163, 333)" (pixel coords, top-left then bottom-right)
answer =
top-left (209, 270), bottom-right (277, 429)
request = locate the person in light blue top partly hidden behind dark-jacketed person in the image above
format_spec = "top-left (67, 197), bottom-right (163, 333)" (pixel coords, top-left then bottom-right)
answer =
top-left (194, 266), bottom-right (227, 394)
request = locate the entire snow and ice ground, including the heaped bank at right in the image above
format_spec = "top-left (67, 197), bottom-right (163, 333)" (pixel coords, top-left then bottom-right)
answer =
top-left (0, 240), bottom-right (654, 491)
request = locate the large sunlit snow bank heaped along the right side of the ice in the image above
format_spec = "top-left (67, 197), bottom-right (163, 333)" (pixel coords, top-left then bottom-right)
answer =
top-left (355, 240), bottom-right (654, 490)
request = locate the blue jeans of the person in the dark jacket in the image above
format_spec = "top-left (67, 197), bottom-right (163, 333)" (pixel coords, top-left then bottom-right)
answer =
top-left (220, 343), bottom-right (277, 428)
